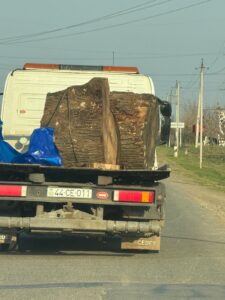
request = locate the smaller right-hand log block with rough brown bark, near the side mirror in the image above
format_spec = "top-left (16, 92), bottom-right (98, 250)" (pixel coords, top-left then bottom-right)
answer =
top-left (110, 92), bottom-right (159, 169)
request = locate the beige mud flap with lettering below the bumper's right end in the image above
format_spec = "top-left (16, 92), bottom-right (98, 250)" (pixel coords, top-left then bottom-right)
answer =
top-left (121, 235), bottom-right (160, 251)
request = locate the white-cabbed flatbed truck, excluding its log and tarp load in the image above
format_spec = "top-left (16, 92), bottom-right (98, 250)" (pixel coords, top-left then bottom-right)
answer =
top-left (0, 63), bottom-right (170, 252)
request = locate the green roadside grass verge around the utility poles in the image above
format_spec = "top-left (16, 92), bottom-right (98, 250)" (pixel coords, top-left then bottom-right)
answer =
top-left (157, 145), bottom-right (225, 192)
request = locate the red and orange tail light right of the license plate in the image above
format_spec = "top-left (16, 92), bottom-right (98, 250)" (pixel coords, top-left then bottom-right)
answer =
top-left (113, 190), bottom-right (155, 203)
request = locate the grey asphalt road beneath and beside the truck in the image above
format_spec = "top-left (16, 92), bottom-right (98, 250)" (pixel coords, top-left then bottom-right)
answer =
top-left (0, 177), bottom-right (225, 300)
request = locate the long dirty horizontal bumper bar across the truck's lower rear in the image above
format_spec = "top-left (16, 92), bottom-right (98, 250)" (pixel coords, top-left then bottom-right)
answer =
top-left (0, 217), bottom-right (161, 235)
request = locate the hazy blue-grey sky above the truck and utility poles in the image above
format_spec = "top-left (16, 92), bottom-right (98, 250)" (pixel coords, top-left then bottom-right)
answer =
top-left (0, 0), bottom-right (225, 115)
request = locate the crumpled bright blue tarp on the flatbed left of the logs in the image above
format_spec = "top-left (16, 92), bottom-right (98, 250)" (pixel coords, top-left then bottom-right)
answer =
top-left (0, 121), bottom-right (63, 166)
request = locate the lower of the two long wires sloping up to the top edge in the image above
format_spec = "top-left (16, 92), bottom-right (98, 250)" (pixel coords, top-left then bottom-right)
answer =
top-left (1, 0), bottom-right (212, 45)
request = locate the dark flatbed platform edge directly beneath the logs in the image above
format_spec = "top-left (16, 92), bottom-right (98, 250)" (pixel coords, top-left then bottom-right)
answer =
top-left (0, 163), bottom-right (170, 183)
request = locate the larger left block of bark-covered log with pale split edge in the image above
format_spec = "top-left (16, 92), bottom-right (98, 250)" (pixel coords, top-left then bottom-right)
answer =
top-left (41, 78), bottom-right (118, 167)
